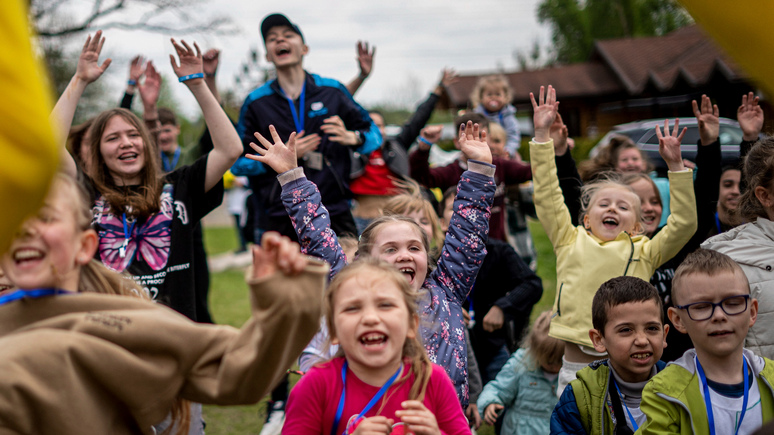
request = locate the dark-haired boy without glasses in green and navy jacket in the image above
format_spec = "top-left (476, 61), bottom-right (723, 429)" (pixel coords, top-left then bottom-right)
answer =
top-left (551, 276), bottom-right (669, 435)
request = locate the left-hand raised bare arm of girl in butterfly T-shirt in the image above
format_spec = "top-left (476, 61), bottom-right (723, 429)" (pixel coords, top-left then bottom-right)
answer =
top-left (51, 30), bottom-right (112, 176)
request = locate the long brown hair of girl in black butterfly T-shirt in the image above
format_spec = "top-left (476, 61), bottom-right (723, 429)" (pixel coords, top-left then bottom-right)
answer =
top-left (89, 109), bottom-right (164, 217)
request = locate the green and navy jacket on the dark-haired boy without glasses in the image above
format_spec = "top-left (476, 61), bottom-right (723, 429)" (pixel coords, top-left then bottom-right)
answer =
top-left (551, 360), bottom-right (666, 435)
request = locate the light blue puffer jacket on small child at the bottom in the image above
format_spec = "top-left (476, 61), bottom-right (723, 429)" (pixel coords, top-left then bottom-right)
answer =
top-left (477, 349), bottom-right (558, 435)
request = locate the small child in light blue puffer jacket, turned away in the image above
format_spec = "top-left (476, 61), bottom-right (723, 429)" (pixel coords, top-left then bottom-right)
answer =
top-left (478, 311), bottom-right (564, 435)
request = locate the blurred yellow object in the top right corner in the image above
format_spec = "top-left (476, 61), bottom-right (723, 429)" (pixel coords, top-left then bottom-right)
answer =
top-left (680, 0), bottom-right (774, 97)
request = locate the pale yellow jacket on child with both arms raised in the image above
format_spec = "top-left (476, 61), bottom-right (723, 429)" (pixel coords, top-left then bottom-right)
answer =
top-left (529, 141), bottom-right (696, 347)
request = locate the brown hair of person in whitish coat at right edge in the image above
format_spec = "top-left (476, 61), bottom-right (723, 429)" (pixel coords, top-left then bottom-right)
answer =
top-left (736, 136), bottom-right (774, 222)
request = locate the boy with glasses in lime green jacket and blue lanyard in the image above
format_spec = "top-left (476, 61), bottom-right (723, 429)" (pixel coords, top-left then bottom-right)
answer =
top-left (642, 249), bottom-right (774, 434)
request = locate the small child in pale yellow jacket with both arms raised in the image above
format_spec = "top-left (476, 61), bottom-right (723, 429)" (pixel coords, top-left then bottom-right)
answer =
top-left (530, 86), bottom-right (696, 394)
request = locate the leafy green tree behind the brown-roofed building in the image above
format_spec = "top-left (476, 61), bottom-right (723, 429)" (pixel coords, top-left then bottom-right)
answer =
top-left (537, 0), bottom-right (692, 63)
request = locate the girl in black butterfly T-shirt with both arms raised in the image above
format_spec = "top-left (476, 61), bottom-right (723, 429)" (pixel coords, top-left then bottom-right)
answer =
top-left (52, 32), bottom-right (242, 320)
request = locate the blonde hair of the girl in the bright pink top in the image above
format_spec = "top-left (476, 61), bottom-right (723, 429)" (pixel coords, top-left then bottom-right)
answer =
top-left (323, 256), bottom-right (433, 403)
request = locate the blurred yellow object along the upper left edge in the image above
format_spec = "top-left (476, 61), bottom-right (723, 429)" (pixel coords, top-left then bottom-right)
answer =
top-left (0, 0), bottom-right (59, 252)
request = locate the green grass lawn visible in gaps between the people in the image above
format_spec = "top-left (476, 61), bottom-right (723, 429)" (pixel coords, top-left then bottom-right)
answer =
top-left (204, 221), bottom-right (556, 435)
